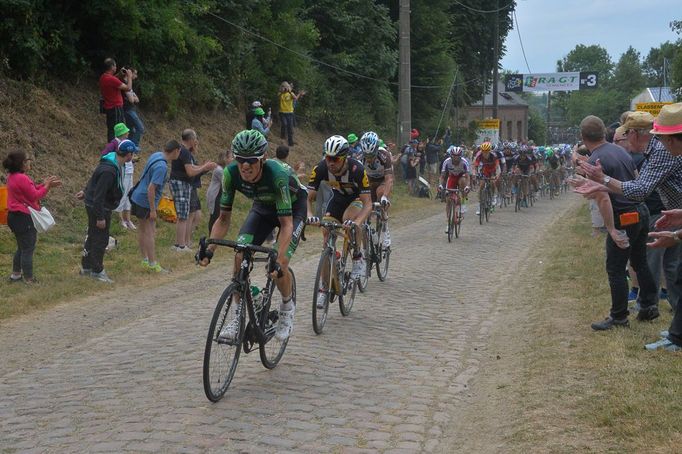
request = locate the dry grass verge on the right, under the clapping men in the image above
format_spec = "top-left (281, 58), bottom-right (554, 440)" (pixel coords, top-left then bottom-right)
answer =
top-left (505, 207), bottom-right (682, 452)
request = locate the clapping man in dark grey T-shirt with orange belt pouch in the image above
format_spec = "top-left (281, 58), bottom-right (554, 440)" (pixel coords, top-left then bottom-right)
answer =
top-left (580, 115), bottom-right (659, 330)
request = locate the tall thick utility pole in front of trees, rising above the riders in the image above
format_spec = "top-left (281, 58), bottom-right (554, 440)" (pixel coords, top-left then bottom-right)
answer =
top-left (398, 0), bottom-right (412, 146)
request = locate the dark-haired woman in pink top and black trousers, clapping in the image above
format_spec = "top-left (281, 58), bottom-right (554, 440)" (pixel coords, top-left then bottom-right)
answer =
top-left (2, 151), bottom-right (62, 283)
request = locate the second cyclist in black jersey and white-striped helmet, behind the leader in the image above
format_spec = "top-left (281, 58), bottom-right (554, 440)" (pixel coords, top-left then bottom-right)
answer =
top-left (308, 135), bottom-right (372, 280)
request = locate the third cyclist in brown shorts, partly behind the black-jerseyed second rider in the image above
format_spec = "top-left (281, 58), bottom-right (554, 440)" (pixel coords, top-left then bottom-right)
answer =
top-left (360, 131), bottom-right (393, 247)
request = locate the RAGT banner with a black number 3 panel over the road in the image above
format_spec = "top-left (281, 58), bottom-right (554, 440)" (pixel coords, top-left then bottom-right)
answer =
top-left (504, 72), bottom-right (598, 92)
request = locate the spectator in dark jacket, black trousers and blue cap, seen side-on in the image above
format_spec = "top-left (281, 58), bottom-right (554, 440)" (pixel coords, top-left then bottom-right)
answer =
top-left (76, 140), bottom-right (137, 284)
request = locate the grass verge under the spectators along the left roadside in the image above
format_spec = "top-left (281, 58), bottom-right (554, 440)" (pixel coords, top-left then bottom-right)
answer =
top-left (0, 183), bottom-right (440, 320)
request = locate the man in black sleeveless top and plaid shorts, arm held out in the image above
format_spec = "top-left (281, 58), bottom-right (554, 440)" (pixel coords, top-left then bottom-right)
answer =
top-left (170, 129), bottom-right (216, 252)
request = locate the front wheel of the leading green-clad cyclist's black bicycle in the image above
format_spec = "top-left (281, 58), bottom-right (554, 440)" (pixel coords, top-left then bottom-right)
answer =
top-left (203, 284), bottom-right (246, 402)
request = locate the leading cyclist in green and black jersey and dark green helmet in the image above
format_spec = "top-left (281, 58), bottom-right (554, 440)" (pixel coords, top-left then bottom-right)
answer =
top-left (196, 130), bottom-right (307, 341)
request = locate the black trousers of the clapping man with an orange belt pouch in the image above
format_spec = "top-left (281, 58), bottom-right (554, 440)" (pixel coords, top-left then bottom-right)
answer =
top-left (606, 204), bottom-right (658, 319)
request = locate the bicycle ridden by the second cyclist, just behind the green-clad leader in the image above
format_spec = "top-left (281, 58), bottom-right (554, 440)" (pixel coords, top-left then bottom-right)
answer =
top-left (313, 221), bottom-right (357, 334)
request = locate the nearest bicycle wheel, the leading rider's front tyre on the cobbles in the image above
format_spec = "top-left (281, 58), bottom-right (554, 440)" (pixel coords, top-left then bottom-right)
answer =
top-left (203, 283), bottom-right (246, 402)
